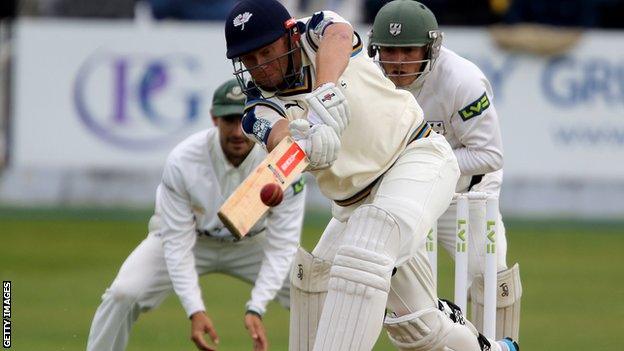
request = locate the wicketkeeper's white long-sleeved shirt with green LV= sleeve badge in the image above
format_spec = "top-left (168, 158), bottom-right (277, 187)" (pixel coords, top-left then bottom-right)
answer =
top-left (410, 47), bottom-right (503, 193)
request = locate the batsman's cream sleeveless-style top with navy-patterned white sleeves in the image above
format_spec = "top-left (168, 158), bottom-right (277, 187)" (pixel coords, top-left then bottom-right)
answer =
top-left (245, 11), bottom-right (423, 200)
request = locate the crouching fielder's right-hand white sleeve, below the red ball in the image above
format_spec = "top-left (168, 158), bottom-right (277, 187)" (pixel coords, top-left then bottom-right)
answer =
top-left (246, 177), bottom-right (305, 315)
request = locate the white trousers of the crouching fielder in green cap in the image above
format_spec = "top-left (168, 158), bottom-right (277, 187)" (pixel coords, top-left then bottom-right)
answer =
top-left (87, 233), bottom-right (290, 351)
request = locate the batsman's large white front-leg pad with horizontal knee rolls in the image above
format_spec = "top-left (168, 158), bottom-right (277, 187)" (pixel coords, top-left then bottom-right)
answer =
top-left (314, 205), bottom-right (399, 351)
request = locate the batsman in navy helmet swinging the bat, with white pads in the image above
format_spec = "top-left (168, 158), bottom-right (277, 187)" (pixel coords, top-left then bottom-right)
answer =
top-left (225, 0), bottom-right (516, 351)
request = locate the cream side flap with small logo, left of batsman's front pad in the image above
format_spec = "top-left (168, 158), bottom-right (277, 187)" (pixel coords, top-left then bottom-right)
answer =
top-left (288, 248), bottom-right (331, 351)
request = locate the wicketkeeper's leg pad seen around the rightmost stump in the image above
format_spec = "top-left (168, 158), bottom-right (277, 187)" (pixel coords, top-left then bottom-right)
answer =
top-left (470, 263), bottom-right (522, 340)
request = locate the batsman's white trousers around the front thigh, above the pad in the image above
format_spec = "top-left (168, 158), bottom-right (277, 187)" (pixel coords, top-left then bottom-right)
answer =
top-left (312, 132), bottom-right (459, 266)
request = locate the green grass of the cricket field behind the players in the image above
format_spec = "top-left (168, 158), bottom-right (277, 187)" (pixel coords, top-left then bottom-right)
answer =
top-left (0, 208), bottom-right (624, 351)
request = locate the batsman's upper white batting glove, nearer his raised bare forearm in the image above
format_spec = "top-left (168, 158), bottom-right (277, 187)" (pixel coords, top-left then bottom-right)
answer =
top-left (306, 83), bottom-right (350, 136)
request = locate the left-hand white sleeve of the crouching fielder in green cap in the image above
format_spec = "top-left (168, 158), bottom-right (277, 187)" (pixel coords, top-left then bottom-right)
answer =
top-left (156, 157), bottom-right (205, 316)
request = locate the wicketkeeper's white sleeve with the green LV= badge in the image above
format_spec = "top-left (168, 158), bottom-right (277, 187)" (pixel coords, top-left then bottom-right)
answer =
top-left (451, 75), bottom-right (503, 175)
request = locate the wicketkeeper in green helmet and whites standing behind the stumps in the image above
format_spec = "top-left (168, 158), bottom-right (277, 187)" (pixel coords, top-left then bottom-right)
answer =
top-left (368, 0), bottom-right (522, 340)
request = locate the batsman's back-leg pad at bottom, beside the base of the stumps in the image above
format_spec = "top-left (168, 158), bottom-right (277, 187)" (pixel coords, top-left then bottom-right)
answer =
top-left (384, 308), bottom-right (481, 351)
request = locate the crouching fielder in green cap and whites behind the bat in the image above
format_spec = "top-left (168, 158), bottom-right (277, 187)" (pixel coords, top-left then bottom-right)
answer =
top-left (87, 80), bottom-right (305, 351)
